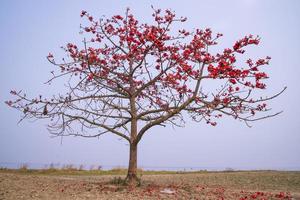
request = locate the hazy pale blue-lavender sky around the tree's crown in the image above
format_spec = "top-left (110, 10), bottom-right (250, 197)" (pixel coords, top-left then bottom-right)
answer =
top-left (0, 0), bottom-right (300, 170)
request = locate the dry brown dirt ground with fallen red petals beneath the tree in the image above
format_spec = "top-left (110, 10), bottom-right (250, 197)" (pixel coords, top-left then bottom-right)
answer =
top-left (0, 172), bottom-right (300, 200)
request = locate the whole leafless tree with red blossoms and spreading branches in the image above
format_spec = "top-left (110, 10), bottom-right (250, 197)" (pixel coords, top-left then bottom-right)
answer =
top-left (6, 9), bottom-right (285, 186)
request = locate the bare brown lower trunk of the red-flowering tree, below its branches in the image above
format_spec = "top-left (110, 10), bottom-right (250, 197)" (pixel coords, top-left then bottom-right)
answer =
top-left (126, 143), bottom-right (138, 186)
